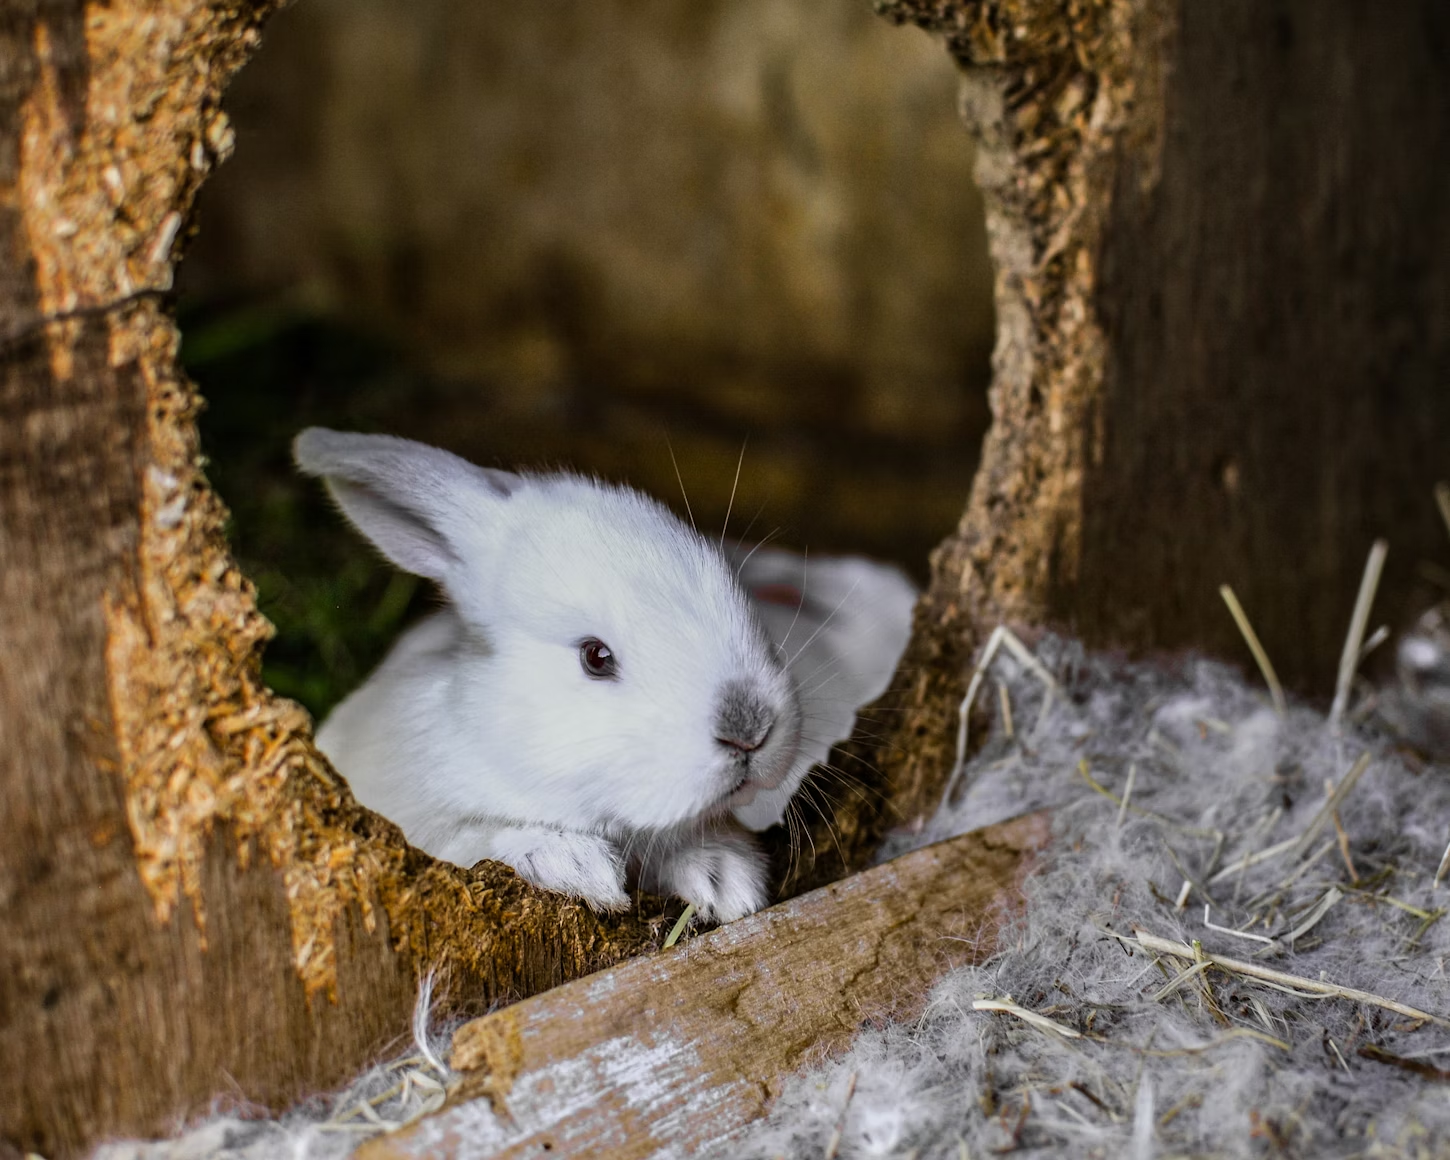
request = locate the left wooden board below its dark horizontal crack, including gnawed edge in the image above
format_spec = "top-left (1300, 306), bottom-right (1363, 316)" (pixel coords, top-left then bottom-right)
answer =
top-left (0, 282), bottom-right (658, 1160)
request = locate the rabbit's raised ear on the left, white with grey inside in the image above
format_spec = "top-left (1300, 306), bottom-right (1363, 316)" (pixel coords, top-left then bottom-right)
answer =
top-left (293, 426), bottom-right (519, 581)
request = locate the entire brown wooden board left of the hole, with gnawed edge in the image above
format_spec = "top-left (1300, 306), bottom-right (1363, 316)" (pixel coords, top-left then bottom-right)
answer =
top-left (0, 0), bottom-right (657, 1157)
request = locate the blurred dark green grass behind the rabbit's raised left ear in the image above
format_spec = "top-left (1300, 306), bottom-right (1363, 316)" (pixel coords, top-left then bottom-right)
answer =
top-left (181, 305), bottom-right (435, 718)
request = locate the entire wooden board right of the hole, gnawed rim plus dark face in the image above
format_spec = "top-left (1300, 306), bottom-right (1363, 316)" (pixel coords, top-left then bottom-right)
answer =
top-left (802, 0), bottom-right (1450, 883)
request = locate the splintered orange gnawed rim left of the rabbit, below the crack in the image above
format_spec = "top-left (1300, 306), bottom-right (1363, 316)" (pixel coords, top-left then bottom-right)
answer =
top-left (106, 303), bottom-right (655, 1011)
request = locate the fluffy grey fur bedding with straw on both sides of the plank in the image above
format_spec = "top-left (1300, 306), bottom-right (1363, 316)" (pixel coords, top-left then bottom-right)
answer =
top-left (90, 638), bottom-right (1450, 1160)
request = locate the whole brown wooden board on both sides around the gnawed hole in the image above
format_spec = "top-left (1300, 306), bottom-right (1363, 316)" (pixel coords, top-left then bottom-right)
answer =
top-left (0, 0), bottom-right (1450, 1157)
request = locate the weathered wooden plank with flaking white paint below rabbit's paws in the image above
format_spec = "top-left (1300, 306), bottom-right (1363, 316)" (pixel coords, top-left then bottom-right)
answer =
top-left (358, 813), bottom-right (1048, 1160)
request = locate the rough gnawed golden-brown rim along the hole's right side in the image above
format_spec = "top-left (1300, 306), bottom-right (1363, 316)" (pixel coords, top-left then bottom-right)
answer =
top-left (792, 0), bottom-right (1171, 886)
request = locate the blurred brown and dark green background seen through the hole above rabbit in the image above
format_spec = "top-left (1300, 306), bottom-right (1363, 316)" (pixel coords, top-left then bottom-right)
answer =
top-left (180, 0), bottom-right (993, 711)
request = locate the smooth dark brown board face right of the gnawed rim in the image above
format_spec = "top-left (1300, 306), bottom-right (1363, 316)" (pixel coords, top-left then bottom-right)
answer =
top-left (1078, 0), bottom-right (1450, 696)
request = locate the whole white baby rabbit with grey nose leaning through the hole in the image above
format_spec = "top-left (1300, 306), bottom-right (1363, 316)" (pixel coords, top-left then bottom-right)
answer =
top-left (296, 428), bottom-right (915, 921)
